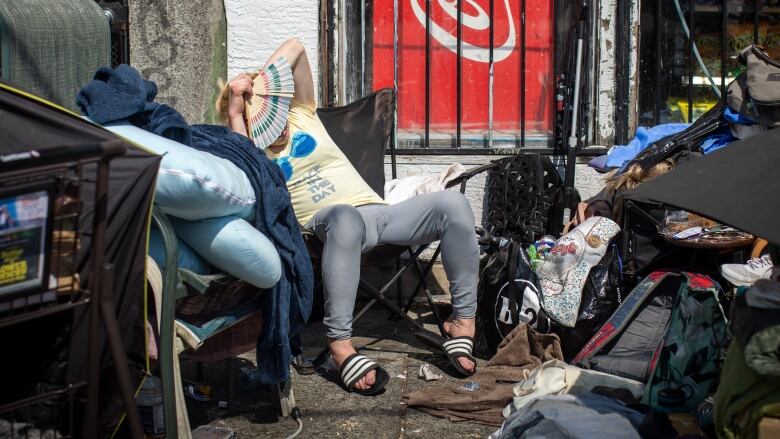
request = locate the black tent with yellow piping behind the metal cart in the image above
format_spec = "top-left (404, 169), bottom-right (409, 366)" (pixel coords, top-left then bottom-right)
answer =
top-left (0, 81), bottom-right (160, 437)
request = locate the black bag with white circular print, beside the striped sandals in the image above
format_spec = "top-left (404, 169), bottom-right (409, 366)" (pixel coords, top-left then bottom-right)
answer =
top-left (476, 241), bottom-right (551, 358)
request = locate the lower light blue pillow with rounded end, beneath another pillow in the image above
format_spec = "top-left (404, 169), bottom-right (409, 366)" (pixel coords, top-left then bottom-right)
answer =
top-left (171, 216), bottom-right (282, 288)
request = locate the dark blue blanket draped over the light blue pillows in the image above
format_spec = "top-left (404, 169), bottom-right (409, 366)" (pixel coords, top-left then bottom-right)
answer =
top-left (77, 65), bottom-right (314, 384)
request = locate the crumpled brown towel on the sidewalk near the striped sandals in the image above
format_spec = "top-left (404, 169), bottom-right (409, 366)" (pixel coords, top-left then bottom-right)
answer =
top-left (403, 323), bottom-right (563, 426)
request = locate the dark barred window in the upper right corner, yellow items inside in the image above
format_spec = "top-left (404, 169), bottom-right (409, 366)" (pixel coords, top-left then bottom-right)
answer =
top-left (639, 0), bottom-right (780, 125)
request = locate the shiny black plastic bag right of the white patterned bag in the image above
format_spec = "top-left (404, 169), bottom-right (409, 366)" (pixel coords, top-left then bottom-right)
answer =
top-left (553, 243), bottom-right (624, 362)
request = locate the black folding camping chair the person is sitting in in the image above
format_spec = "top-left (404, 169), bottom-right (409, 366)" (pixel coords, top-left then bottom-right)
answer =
top-left (294, 88), bottom-right (494, 374)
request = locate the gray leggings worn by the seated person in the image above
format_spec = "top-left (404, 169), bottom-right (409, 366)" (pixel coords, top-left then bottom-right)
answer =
top-left (308, 191), bottom-right (479, 340)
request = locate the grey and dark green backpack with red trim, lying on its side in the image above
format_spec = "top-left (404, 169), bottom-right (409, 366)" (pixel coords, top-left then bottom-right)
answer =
top-left (573, 271), bottom-right (728, 413)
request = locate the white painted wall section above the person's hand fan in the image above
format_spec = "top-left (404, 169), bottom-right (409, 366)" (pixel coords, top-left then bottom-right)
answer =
top-left (224, 0), bottom-right (319, 96)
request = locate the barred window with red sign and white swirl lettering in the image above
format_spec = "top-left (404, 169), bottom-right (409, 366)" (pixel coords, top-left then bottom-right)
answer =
top-left (320, 0), bottom-right (587, 154)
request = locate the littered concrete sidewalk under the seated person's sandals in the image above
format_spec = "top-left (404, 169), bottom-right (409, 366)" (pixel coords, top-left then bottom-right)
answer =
top-left (182, 306), bottom-right (495, 439)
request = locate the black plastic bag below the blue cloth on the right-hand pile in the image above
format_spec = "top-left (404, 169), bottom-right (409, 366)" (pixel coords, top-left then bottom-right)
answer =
top-left (625, 99), bottom-right (728, 169)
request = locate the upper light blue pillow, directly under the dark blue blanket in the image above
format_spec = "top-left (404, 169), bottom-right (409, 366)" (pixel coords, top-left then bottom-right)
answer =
top-left (105, 122), bottom-right (255, 220)
